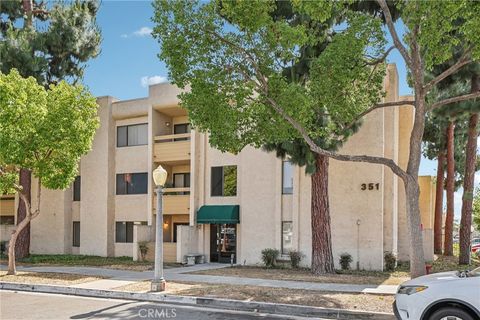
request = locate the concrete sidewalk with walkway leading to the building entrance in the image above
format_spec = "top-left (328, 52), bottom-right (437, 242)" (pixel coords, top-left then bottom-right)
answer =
top-left (0, 263), bottom-right (398, 295)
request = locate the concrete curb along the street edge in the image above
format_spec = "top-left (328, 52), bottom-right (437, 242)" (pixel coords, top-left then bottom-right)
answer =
top-left (0, 282), bottom-right (395, 320)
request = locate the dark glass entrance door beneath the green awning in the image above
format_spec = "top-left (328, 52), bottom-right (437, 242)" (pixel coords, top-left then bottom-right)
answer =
top-left (210, 224), bottom-right (237, 263)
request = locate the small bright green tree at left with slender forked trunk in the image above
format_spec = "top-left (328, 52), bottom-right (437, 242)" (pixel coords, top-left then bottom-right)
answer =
top-left (0, 69), bottom-right (99, 274)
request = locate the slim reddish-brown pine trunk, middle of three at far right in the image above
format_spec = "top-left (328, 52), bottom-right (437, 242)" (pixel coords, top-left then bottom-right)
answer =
top-left (443, 121), bottom-right (455, 256)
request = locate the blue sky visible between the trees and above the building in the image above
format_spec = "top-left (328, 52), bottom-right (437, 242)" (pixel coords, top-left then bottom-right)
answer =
top-left (84, 0), bottom-right (472, 217)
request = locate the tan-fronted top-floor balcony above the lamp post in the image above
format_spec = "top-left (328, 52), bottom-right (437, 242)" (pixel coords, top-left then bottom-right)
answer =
top-left (153, 133), bottom-right (190, 163)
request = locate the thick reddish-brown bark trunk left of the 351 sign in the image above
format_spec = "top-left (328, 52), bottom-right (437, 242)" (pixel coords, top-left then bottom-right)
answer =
top-left (311, 154), bottom-right (335, 274)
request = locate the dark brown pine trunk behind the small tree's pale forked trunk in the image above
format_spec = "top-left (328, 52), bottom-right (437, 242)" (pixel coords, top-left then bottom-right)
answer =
top-left (15, 169), bottom-right (32, 259)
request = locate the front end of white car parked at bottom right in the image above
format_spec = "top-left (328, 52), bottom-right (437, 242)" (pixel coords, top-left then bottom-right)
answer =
top-left (393, 268), bottom-right (480, 320)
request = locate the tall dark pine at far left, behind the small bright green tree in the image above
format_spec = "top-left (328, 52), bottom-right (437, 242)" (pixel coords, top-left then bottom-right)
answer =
top-left (0, 0), bottom-right (101, 258)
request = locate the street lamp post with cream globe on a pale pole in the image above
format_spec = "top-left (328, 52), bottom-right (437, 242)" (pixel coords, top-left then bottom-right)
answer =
top-left (151, 166), bottom-right (168, 291)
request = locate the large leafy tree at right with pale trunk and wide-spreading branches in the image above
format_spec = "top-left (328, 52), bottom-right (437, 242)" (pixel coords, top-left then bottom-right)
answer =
top-left (153, 0), bottom-right (480, 277)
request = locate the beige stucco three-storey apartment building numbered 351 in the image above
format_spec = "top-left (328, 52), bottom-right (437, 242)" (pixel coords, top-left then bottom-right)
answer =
top-left (1, 65), bottom-right (435, 270)
